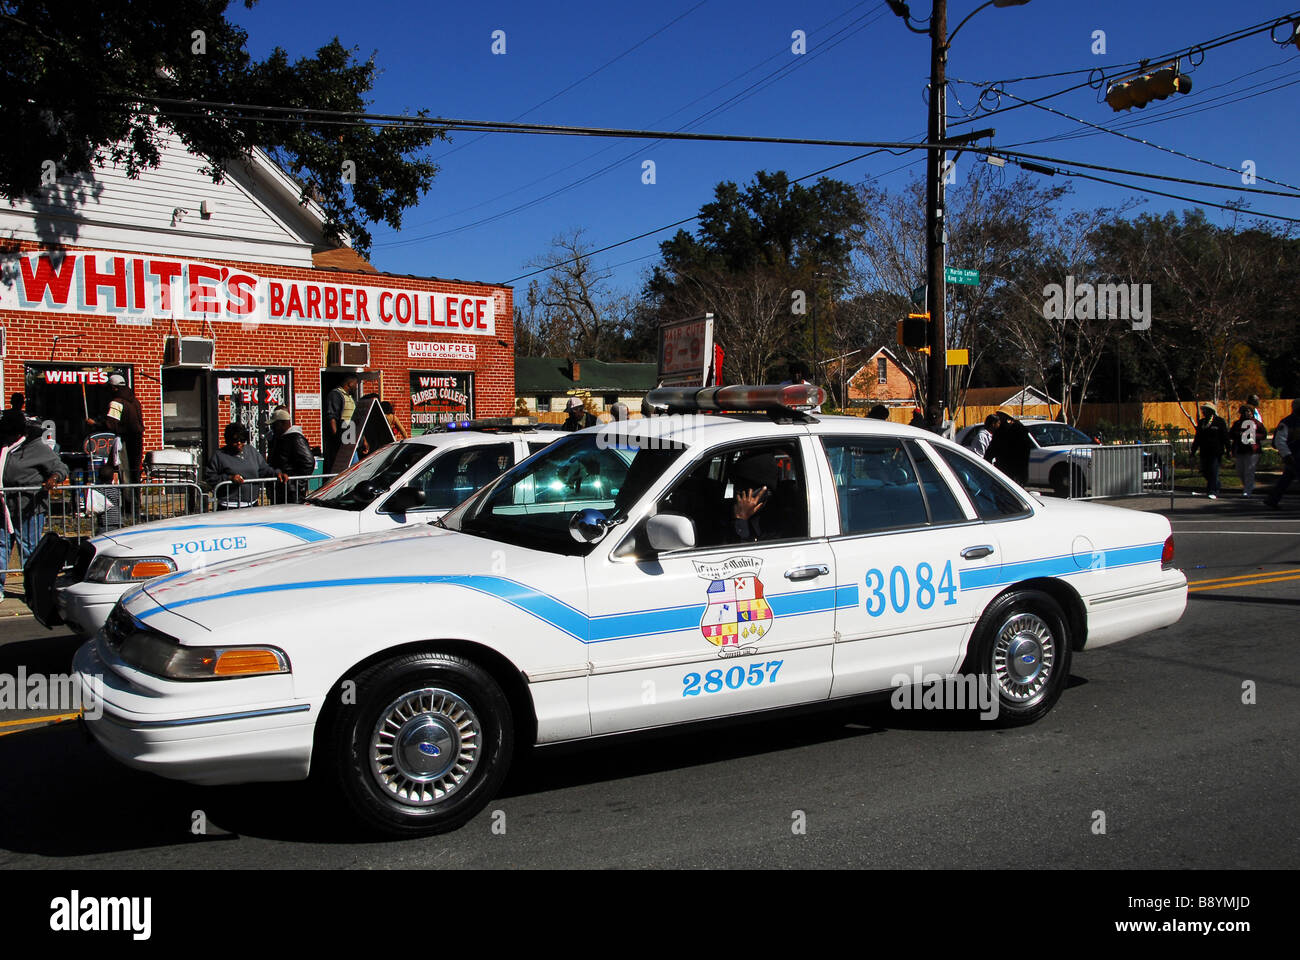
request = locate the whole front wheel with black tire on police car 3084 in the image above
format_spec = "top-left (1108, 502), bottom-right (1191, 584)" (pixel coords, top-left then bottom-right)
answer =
top-left (326, 653), bottom-right (515, 836)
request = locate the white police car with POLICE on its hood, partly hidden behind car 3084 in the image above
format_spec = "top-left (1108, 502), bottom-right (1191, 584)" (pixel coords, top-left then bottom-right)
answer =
top-left (29, 418), bottom-right (564, 635)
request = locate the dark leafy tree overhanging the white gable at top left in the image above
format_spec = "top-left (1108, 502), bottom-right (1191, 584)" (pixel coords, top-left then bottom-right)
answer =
top-left (0, 0), bottom-right (446, 252)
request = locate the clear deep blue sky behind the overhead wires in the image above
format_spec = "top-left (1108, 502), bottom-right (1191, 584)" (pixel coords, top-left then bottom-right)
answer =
top-left (229, 0), bottom-right (1300, 290)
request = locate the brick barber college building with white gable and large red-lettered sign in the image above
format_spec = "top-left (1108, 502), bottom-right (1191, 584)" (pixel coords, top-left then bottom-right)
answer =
top-left (0, 130), bottom-right (515, 468)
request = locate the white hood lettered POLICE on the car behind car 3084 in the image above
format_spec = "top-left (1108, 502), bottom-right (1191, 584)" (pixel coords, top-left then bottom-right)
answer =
top-left (92, 503), bottom-right (343, 559)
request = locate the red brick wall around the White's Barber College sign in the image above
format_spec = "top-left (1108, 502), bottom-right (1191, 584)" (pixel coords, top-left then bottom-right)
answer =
top-left (0, 241), bottom-right (515, 450)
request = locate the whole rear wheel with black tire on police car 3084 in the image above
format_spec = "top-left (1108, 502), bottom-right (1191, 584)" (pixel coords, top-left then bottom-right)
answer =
top-left (962, 589), bottom-right (1073, 726)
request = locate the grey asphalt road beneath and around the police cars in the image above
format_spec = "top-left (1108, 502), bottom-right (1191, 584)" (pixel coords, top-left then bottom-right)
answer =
top-left (0, 501), bottom-right (1300, 869)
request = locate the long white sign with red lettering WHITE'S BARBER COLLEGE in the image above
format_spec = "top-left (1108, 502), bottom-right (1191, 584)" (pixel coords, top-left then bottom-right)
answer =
top-left (0, 250), bottom-right (504, 337)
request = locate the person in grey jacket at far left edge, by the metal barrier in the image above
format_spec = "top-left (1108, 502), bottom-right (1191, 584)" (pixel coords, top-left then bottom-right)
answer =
top-left (0, 420), bottom-right (68, 591)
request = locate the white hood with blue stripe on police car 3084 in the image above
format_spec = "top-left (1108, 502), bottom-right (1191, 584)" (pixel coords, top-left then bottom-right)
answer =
top-left (124, 524), bottom-right (501, 635)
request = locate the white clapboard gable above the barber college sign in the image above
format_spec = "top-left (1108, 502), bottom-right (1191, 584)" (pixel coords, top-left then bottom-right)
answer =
top-left (0, 130), bottom-right (329, 267)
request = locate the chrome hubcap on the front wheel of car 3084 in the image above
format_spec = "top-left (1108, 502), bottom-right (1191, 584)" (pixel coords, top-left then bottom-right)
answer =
top-left (371, 687), bottom-right (482, 807)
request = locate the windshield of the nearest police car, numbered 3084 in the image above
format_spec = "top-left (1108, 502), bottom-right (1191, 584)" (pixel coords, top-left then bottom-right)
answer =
top-left (442, 431), bottom-right (686, 554)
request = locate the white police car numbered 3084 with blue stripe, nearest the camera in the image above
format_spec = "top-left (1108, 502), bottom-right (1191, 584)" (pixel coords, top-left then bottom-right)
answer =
top-left (75, 385), bottom-right (1187, 835)
